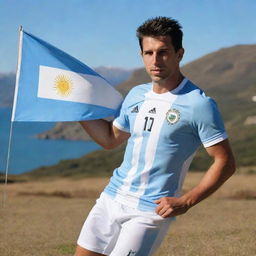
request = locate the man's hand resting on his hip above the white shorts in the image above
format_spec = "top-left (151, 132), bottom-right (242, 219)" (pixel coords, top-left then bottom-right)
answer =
top-left (155, 197), bottom-right (189, 218)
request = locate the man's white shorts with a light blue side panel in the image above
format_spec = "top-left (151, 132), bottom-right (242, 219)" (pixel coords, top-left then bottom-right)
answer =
top-left (77, 192), bottom-right (174, 256)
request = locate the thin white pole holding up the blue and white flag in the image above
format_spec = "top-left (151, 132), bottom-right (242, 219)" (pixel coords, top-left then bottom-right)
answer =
top-left (2, 25), bottom-right (23, 208)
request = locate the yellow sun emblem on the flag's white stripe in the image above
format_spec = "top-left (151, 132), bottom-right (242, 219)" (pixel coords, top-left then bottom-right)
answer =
top-left (54, 75), bottom-right (73, 97)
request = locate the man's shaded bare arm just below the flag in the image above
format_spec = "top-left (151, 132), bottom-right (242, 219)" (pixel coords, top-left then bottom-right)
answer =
top-left (80, 119), bottom-right (130, 149)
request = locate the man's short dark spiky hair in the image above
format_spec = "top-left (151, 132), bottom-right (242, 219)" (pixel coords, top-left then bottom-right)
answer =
top-left (137, 17), bottom-right (183, 52)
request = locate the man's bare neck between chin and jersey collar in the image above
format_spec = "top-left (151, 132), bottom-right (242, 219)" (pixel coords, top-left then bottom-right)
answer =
top-left (153, 73), bottom-right (184, 94)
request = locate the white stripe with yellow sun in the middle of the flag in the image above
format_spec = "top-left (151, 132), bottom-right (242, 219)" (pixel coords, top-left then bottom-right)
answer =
top-left (37, 66), bottom-right (122, 109)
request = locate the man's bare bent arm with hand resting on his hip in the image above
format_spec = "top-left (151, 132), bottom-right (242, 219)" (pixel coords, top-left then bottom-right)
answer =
top-left (156, 140), bottom-right (235, 218)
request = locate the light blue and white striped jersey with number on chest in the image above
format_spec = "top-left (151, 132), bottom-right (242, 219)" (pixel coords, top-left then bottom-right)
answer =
top-left (105, 78), bottom-right (227, 211)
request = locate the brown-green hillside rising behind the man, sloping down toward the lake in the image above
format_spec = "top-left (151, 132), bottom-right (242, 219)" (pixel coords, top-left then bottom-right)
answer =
top-left (22, 45), bottom-right (256, 178)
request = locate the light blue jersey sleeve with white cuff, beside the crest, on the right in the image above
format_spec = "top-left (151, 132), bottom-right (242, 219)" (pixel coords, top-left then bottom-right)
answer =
top-left (192, 98), bottom-right (228, 147)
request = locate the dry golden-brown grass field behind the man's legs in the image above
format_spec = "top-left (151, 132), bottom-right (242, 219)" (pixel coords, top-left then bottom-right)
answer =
top-left (0, 173), bottom-right (256, 256)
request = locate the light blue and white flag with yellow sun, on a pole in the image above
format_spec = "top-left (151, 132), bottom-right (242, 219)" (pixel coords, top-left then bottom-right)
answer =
top-left (12, 28), bottom-right (122, 122)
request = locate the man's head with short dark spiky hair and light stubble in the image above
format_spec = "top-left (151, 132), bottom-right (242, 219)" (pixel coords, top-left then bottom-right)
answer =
top-left (137, 17), bottom-right (184, 88)
